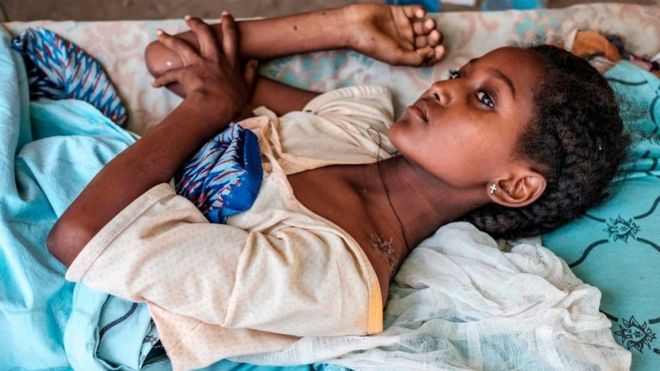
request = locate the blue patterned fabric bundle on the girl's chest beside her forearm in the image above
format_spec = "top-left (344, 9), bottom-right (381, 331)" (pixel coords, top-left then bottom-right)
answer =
top-left (175, 124), bottom-right (263, 223)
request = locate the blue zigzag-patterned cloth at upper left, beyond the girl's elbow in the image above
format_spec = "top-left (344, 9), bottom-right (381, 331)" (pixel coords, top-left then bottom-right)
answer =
top-left (12, 27), bottom-right (128, 127)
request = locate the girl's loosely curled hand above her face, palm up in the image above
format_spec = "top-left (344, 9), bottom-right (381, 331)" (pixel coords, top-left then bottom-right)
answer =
top-left (346, 4), bottom-right (445, 66)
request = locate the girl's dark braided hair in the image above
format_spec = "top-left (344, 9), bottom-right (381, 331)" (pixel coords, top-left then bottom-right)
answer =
top-left (465, 45), bottom-right (630, 238)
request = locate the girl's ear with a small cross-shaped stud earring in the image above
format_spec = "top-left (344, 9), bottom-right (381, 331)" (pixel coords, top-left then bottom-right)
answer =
top-left (487, 169), bottom-right (547, 207)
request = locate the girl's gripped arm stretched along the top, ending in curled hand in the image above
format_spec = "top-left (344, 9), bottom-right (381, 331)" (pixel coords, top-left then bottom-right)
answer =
top-left (145, 4), bottom-right (444, 115)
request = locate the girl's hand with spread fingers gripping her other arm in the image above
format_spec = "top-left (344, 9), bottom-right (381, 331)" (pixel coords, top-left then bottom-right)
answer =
top-left (153, 12), bottom-right (257, 122)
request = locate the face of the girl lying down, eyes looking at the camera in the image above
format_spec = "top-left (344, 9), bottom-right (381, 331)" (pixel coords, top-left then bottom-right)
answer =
top-left (388, 47), bottom-right (543, 187)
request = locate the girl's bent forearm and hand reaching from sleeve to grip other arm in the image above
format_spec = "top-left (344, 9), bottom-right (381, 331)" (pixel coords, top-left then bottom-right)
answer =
top-left (46, 14), bottom-right (256, 267)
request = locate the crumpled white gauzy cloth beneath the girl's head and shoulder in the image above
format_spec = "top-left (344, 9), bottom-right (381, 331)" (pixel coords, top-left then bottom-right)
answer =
top-left (232, 222), bottom-right (631, 370)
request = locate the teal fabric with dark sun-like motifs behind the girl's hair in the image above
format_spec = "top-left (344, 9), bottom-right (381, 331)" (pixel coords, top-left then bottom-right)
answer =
top-left (543, 62), bottom-right (660, 371)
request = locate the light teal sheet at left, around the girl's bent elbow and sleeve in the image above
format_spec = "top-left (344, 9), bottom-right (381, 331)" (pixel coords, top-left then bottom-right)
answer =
top-left (0, 29), bottom-right (341, 371)
